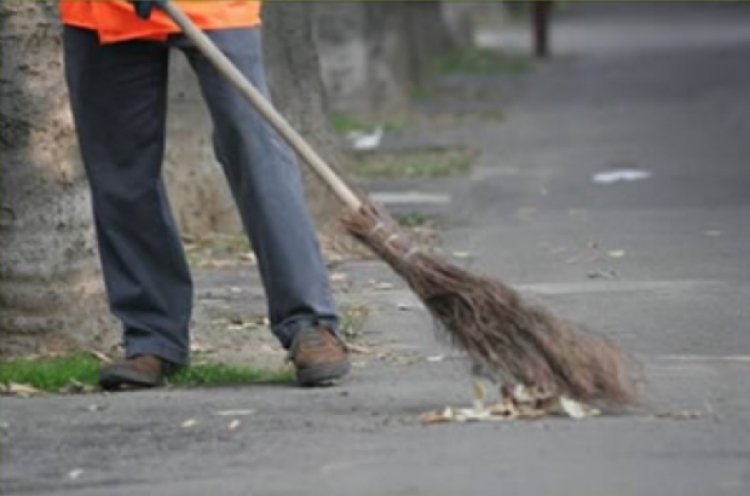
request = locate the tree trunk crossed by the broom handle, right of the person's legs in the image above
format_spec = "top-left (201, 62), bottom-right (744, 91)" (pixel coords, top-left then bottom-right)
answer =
top-left (263, 2), bottom-right (354, 234)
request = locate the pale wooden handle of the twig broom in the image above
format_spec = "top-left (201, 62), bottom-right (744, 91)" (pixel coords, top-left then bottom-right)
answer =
top-left (159, 0), bottom-right (362, 210)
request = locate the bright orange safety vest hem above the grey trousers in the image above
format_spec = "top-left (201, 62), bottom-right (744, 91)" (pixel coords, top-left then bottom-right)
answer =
top-left (60, 0), bottom-right (261, 43)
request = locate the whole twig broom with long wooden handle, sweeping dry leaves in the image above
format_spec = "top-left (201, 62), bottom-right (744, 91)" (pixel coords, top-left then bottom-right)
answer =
top-left (159, 1), bottom-right (637, 406)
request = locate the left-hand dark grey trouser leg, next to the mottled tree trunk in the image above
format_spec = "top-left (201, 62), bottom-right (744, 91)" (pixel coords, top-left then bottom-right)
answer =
top-left (64, 27), bottom-right (192, 365)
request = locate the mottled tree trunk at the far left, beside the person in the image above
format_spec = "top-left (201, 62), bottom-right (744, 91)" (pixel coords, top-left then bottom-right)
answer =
top-left (0, 2), bottom-right (117, 356)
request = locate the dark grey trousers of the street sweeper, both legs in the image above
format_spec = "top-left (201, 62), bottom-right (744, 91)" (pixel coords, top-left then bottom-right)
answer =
top-left (64, 26), bottom-right (338, 364)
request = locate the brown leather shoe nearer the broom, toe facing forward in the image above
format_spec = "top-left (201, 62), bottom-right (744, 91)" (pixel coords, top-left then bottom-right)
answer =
top-left (289, 327), bottom-right (351, 386)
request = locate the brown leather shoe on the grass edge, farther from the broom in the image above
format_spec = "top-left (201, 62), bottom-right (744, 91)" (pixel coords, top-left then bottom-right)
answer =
top-left (99, 355), bottom-right (176, 391)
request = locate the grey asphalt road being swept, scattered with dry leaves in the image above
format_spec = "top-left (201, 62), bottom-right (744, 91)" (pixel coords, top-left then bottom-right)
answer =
top-left (2, 4), bottom-right (750, 496)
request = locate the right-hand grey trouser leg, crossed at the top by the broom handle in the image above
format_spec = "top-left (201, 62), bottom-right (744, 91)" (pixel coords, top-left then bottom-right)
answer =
top-left (175, 28), bottom-right (339, 348)
